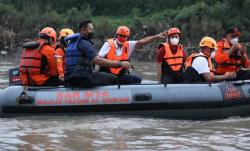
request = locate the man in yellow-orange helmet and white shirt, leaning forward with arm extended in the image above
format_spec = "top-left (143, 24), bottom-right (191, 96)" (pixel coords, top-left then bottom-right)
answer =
top-left (184, 37), bottom-right (236, 83)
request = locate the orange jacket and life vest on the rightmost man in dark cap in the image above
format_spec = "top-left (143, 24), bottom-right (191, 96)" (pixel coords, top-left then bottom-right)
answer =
top-left (215, 39), bottom-right (244, 74)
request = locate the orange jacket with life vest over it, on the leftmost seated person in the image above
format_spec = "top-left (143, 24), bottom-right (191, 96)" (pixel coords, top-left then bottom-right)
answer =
top-left (20, 40), bottom-right (58, 86)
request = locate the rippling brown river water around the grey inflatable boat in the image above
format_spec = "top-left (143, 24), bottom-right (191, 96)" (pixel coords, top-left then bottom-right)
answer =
top-left (0, 62), bottom-right (250, 151)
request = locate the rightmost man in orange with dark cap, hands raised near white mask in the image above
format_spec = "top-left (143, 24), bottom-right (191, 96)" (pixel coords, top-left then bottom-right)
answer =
top-left (214, 27), bottom-right (250, 80)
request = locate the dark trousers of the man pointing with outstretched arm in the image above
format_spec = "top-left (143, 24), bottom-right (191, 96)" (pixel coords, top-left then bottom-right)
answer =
top-left (119, 74), bottom-right (142, 84)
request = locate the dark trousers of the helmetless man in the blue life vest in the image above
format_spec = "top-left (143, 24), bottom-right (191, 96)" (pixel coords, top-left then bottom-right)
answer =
top-left (65, 72), bottom-right (118, 87)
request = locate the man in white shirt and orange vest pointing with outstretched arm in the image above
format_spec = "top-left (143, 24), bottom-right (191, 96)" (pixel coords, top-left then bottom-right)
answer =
top-left (99, 26), bottom-right (165, 84)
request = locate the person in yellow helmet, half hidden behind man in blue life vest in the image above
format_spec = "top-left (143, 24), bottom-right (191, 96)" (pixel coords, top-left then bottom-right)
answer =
top-left (55, 28), bottom-right (74, 81)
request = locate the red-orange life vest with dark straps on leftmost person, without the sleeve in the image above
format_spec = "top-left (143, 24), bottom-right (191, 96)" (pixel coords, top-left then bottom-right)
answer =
top-left (20, 42), bottom-right (44, 75)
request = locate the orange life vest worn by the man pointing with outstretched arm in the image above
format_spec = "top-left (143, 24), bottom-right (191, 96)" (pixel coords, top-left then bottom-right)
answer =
top-left (107, 39), bottom-right (129, 75)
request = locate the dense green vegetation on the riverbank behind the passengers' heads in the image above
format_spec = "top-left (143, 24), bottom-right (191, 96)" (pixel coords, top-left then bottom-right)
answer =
top-left (0, 0), bottom-right (250, 50)
